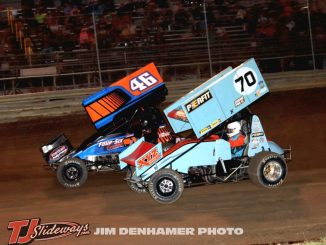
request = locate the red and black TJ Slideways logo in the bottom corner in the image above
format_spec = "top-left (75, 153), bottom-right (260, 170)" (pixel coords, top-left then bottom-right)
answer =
top-left (7, 218), bottom-right (90, 245)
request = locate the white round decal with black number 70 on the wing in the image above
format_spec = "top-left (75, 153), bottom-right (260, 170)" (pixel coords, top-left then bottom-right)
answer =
top-left (233, 67), bottom-right (257, 95)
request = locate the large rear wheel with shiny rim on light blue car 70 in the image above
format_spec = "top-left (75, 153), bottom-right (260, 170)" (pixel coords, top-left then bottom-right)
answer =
top-left (248, 151), bottom-right (287, 188)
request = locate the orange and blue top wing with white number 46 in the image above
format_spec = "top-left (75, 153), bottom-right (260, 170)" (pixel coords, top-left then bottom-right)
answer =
top-left (83, 63), bottom-right (167, 129)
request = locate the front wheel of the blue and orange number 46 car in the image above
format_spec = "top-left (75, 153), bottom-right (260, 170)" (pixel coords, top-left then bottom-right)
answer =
top-left (57, 158), bottom-right (88, 188)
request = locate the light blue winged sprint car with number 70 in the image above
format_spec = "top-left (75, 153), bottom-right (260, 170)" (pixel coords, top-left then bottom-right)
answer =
top-left (119, 59), bottom-right (291, 204)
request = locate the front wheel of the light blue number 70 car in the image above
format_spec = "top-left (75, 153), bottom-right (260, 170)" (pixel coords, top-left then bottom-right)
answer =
top-left (148, 168), bottom-right (184, 204)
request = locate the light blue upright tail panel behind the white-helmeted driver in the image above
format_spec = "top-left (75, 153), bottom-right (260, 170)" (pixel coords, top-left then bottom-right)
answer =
top-left (248, 115), bottom-right (270, 157)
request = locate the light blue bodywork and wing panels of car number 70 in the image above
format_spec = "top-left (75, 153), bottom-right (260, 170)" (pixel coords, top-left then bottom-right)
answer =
top-left (119, 59), bottom-right (284, 181)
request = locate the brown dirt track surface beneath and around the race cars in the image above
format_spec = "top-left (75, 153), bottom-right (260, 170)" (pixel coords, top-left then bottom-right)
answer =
top-left (0, 89), bottom-right (326, 244)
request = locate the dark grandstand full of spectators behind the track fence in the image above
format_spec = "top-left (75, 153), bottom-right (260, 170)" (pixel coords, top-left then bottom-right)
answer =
top-left (0, 0), bottom-right (326, 94)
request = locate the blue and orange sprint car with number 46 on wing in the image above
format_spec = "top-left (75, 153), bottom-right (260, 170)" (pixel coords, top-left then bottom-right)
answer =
top-left (41, 63), bottom-right (173, 187)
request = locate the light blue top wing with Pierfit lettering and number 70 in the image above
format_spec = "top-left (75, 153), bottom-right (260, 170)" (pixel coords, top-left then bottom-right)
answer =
top-left (164, 59), bottom-right (268, 138)
